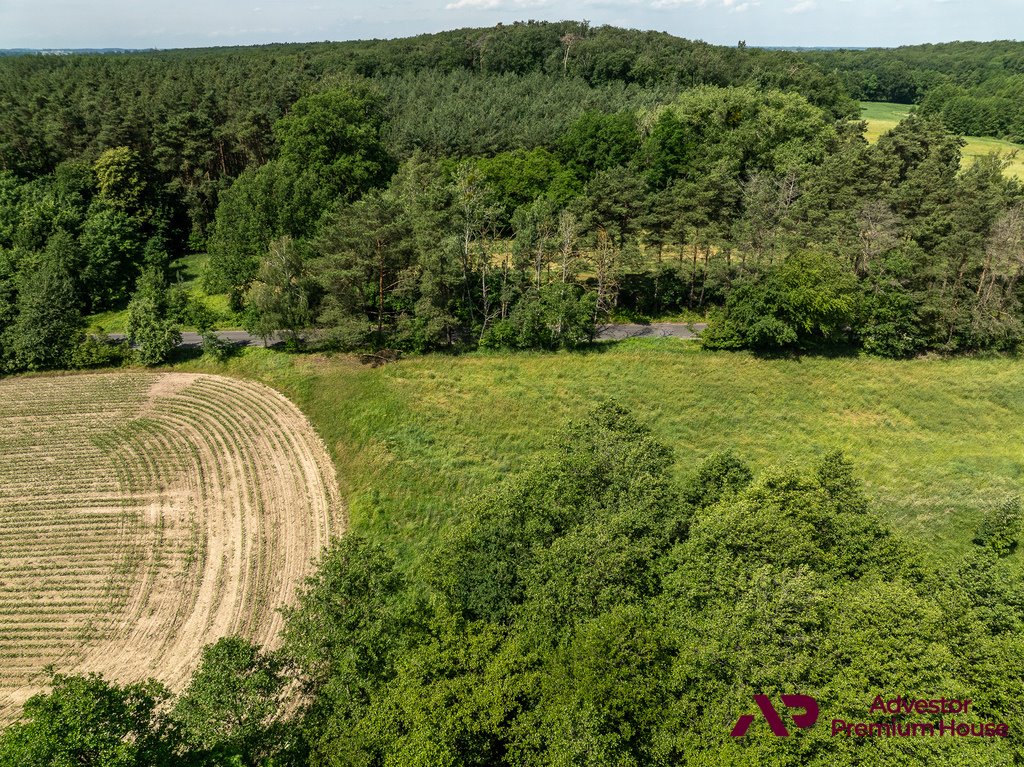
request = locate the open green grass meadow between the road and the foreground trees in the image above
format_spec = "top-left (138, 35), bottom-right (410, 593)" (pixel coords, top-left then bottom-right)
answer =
top-left (176, 339), bottom-right (1024, 567)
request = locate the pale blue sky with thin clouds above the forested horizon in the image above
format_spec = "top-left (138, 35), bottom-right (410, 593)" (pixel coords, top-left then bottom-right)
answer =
top-left (0, 0), bottom-right (1024, 48)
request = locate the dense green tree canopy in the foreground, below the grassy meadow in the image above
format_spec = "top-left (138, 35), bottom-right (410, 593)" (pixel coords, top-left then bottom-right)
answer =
top-left (0, 404), bottom-right (1024, 767)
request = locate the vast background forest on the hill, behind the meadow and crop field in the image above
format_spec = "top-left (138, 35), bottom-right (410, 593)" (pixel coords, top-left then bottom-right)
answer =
top-left (0, 23), bottom-right (1024, 371)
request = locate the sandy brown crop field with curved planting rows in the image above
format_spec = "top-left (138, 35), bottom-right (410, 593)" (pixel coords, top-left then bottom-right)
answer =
top-left (0, 371), bottom-right (342, 720)
